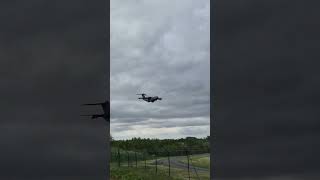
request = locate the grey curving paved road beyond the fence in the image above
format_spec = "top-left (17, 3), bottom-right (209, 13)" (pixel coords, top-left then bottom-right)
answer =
top-left (152, 156), bottom-right (210, 172)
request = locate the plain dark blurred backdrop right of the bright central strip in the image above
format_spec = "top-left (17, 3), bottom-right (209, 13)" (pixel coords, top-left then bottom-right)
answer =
top-left (213, 0), bottom-right (320, 179)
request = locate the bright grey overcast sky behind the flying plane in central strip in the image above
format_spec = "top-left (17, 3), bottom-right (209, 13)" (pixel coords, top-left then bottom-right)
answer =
top-left (110, 0), bottom-right (210, 139)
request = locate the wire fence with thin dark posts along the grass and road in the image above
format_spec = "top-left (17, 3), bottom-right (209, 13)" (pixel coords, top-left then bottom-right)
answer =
top-left (111, 148), bottom-right (210, 180)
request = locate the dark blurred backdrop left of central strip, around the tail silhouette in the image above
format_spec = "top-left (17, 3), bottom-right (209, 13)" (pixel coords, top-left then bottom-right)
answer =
top-left (0, 0), bottom-right (108, 180)
